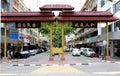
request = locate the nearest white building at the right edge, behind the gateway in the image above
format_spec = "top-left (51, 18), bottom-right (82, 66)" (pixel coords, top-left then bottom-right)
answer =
top-left (97, 0), bottom-right (120, 57)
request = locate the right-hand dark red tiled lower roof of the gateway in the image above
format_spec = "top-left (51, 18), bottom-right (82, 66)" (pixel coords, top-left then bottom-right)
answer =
top-left (58, 11), bottom-right (118, 22)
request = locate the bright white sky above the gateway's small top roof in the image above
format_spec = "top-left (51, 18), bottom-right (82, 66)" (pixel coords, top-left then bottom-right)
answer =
top-left (24, 0), bottom-right (86, 11)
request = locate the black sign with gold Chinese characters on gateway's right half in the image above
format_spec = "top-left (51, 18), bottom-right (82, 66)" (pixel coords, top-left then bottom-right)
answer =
top-left (73, 22), bottom-right (97, 28)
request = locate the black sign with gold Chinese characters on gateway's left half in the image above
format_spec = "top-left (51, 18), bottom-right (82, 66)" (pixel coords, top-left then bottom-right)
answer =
top-left (16, 22), bottom-right (40, 28)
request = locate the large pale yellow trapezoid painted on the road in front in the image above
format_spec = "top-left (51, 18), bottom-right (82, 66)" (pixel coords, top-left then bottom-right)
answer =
top-left (31, 66), bottom-right (84, 74)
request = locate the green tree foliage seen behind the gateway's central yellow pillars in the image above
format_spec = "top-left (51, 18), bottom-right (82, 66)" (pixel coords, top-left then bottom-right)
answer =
top-left (39, 22), bottom-right (74, 47)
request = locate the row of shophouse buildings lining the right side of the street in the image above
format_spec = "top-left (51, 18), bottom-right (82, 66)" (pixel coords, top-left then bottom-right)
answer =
top-left (71, 0), bottom-right (120, 57)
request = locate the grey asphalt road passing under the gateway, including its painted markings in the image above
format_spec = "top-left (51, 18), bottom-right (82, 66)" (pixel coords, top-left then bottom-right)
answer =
top-left (0, 52), bottom-right (120, 76)
